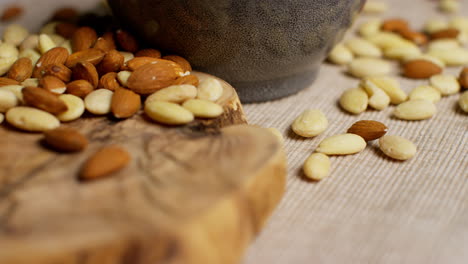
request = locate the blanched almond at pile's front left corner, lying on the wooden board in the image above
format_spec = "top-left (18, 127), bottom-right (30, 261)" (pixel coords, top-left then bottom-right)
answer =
top-left (6, 106), bottom-right (60, 132)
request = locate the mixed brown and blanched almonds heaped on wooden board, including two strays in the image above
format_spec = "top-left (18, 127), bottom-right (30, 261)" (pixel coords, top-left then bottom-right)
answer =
top-left (0, 8), bottom-right (224, 182)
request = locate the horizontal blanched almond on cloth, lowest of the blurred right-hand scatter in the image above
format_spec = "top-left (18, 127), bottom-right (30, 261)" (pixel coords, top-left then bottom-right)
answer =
top-left (393, 99), bottom-right (437, 121)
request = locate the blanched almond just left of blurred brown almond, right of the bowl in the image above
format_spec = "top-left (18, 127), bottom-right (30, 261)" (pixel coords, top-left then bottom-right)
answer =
top-left (348, 58), bottom-right (392, 78)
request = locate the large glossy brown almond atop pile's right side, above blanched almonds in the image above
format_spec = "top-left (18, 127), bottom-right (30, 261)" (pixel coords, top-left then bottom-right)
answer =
top-left (127, 60), bottom-right (184, 94)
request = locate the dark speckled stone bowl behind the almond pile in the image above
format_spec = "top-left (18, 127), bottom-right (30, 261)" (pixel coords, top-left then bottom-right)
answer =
top-left (108, 0), bottom-right (365, 103)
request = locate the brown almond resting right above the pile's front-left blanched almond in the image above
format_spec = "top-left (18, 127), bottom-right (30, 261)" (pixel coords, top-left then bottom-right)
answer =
top-left (21, 87), bottom-right (68, 114)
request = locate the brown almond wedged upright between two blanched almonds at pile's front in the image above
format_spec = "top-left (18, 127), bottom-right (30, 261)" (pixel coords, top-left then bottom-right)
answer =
top-left (111, 88), bottom-right (141, 118)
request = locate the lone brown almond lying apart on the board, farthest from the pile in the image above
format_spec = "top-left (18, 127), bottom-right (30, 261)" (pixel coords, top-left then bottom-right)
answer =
top-left (80, 146), bottom-right (131, 181)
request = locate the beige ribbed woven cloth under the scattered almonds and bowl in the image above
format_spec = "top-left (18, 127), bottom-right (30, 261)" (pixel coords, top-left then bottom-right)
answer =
top-left (0, 0), bottom-right (468, 264)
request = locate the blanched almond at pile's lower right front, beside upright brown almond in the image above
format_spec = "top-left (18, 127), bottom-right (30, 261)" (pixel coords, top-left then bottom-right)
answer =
top-left (145, 101), bottom-right (195, 125)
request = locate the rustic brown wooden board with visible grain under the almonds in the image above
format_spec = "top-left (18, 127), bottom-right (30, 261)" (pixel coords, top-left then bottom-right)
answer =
top-left (0, 73), bottom-right (286, 264)
